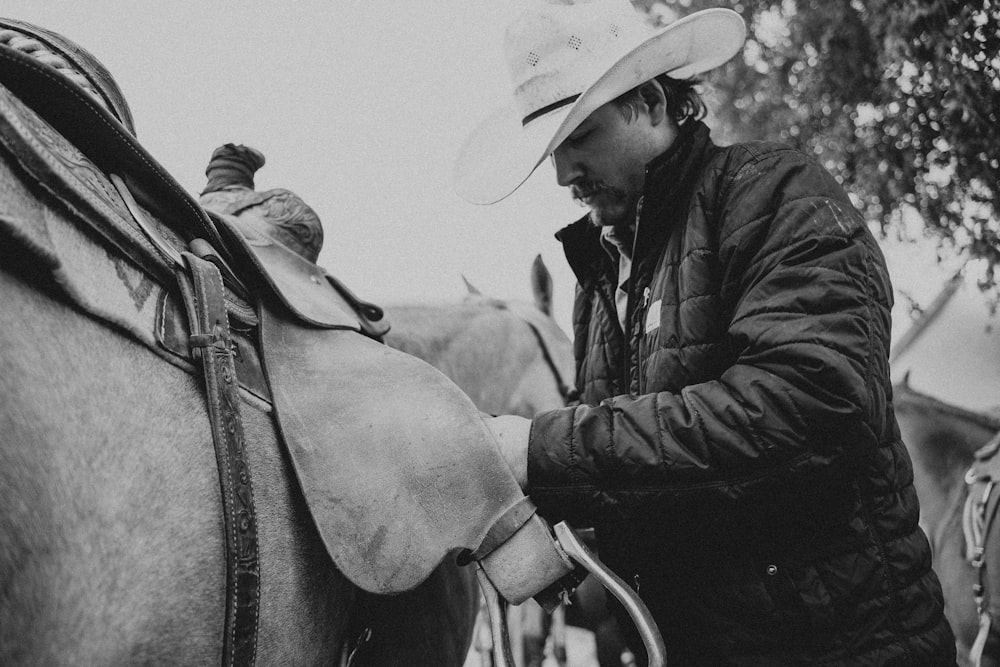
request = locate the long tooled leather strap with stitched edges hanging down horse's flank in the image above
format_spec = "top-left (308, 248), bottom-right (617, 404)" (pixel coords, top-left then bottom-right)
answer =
top-left (177, 253), bottom-right (260, 666)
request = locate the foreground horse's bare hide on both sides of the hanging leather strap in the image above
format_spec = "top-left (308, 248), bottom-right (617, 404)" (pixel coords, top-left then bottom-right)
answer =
top-left (0, 251), bottom-right (353, 664)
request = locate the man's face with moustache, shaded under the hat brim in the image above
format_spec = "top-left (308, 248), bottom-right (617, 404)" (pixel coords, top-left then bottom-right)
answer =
top-left (552, 102), bottom-right (663, 226)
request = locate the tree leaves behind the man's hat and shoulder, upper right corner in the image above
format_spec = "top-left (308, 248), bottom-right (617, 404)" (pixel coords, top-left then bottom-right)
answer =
top-left (635, 0), bottom-right (1000, 274)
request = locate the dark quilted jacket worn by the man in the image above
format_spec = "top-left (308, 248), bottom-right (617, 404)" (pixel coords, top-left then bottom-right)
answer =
top-left (528, 123), bottom-right (955, 666)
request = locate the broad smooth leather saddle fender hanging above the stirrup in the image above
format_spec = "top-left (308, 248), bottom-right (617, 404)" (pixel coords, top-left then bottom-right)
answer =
top-left (260, 303), bottom-right (524, 593)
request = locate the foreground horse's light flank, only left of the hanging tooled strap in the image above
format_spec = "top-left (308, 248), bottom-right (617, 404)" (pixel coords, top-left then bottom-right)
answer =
top-left (0, 264), bottom-right (223, 664)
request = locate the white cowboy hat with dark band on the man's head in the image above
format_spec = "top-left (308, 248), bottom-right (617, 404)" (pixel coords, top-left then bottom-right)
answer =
top-left (453, 0), bottom-right (746, 204)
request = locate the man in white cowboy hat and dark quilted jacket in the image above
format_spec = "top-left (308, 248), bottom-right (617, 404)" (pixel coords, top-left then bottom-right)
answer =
top-left (456, 0), bottom-right (955, 666)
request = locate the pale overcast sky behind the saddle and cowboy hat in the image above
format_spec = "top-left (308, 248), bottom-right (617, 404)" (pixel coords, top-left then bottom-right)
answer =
top-left (0, 0), bottom-right (960, 340)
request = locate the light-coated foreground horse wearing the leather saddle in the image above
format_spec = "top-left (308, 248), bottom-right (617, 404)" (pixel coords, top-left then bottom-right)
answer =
top-left (0, 19), bottom-right (584, 665)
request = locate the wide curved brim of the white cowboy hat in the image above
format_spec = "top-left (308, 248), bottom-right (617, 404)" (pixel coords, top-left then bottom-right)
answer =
top-left (452, 9), bottom-right (746, 204)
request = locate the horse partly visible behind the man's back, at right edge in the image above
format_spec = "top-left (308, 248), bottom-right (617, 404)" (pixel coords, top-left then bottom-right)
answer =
top-left (893, 378), bottom-right (1000, 665)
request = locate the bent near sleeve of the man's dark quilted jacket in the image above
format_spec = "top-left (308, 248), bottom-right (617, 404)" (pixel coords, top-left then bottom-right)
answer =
top-left (528, 151), bottom-right (891, 519)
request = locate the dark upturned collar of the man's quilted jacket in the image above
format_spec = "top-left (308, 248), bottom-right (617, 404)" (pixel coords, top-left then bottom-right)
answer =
top-left (556, 120), bottom-right (713, 288)
